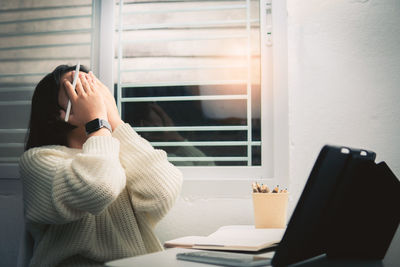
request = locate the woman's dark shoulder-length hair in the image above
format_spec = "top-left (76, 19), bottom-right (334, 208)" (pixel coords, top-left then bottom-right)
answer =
top-left (25, 65), bottom-right (89, 151)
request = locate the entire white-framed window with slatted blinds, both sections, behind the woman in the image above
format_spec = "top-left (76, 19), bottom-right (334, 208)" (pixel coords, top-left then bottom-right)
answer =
top-left (0, 0), bottom-right (288, 183)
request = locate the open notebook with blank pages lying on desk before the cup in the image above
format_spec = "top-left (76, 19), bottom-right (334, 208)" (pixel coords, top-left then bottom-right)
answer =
top-left (164, 225), bottom-right (285, 251)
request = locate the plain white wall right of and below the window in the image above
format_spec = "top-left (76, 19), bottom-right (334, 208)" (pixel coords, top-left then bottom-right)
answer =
top-left (157, 0), bottom-right (400, 243)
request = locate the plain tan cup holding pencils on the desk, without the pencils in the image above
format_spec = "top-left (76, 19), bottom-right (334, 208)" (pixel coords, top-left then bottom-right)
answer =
top-left (253, 193), bottom-right (289, 228)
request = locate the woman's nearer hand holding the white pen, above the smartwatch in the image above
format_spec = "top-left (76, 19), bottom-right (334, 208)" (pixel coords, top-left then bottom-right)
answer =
top-left (61, 73), bottom-right (108, 126)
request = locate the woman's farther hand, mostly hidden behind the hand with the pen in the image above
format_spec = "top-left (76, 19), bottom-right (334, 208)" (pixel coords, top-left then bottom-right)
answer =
top-left (87, 72), bottom-right (123, 130)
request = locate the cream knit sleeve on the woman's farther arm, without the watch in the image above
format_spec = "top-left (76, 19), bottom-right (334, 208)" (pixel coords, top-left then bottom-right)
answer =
top-left (113, 123), bottom-right (182, 225)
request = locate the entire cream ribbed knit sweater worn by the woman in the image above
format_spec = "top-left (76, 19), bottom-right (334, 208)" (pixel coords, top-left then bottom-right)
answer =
top-left (20, 124), bottom-right (182, 267)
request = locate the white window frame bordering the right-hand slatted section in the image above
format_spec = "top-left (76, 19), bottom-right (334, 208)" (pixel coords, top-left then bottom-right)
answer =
top-left (90, 0), bottom-right (289, 185)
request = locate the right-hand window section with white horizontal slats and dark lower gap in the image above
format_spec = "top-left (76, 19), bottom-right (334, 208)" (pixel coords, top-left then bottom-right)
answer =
top-left (114, 0), bottom-right (272, 178)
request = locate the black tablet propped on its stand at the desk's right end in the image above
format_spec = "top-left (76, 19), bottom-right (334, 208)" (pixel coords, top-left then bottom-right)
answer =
top-left (272, 145), bottom-right (400, 266)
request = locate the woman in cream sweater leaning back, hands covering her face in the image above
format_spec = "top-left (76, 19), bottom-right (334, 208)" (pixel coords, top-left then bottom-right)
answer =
top-left (20, 65), bottom-right (182, 266)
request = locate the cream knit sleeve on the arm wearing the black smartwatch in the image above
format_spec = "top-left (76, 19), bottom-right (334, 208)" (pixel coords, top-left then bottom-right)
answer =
top-left (20, 136), bottom-right (126, 224)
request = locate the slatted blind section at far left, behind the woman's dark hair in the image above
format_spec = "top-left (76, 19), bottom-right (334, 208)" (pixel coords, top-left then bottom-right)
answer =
top-left (0, 0), bottom-right (95, 178)
